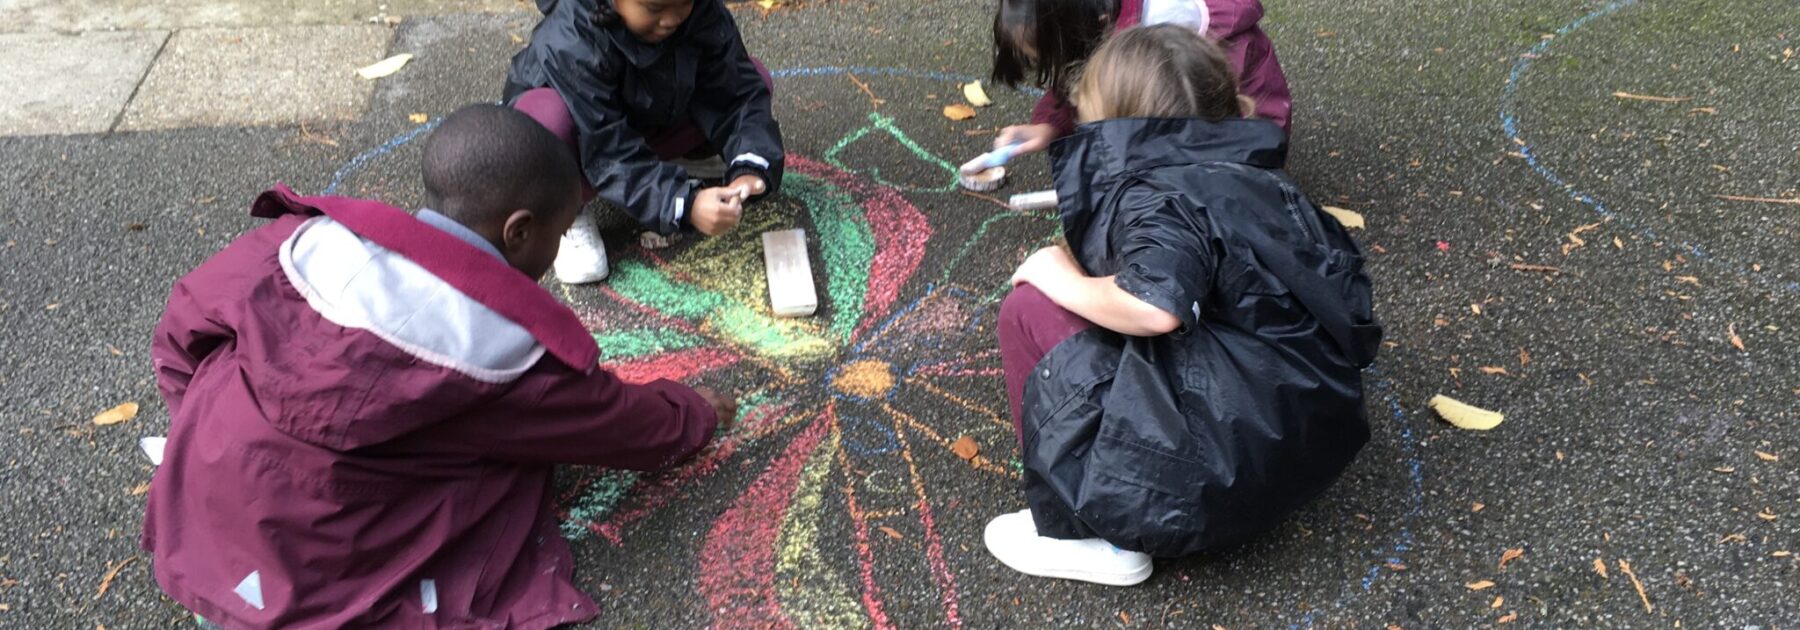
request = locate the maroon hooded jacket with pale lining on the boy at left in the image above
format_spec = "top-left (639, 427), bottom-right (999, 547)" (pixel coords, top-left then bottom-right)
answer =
top-left (142, 187), bottom-right (716, 628)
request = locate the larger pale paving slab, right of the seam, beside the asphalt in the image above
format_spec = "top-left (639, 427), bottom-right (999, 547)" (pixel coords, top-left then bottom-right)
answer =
top-left (119, 25), bottom-right (394, 130)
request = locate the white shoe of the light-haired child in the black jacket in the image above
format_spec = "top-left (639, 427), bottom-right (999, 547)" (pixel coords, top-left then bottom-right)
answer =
top-left (983, 509), bottom-right (1150, 587)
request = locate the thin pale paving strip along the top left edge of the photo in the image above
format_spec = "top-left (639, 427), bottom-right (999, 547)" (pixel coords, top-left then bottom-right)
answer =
top-left (0, 0), bottom-right (535, 32)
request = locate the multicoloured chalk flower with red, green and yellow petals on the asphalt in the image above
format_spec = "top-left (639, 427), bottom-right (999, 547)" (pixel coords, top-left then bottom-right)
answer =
top-left (562, 150), bottom-right (1046, 628)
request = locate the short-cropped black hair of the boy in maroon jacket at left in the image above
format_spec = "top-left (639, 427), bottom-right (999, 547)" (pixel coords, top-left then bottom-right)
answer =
top-left (419, 104), bottom-right (581, 227)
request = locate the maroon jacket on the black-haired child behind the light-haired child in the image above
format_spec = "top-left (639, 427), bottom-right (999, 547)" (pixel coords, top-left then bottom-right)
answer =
top-left (1031, 0), bottom-right (1294, 139)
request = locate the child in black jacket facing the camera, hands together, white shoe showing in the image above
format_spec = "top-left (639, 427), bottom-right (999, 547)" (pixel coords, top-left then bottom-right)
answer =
top-left (506, 0), bottom-right (785, 283)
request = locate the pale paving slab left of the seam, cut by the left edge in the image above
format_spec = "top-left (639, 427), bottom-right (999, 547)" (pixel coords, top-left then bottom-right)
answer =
top-left (0, 31), bottom-right (169, 135)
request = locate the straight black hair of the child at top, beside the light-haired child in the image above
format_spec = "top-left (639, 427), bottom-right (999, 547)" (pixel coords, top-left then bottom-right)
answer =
top-left (992, 0), bottom-right (1118, 95)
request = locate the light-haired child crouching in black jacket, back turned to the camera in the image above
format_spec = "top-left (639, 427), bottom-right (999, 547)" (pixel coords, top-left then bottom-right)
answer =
top-left (985, 25), bottom-right (1381, 585)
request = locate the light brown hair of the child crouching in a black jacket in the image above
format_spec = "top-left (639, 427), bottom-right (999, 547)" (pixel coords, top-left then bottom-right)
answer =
top-left (1075, 23), bottom-right (1244, 121)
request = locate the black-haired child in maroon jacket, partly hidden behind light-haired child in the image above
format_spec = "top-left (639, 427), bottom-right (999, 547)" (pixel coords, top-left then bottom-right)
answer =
top-left (994, 0), bottom-right (1292, 153)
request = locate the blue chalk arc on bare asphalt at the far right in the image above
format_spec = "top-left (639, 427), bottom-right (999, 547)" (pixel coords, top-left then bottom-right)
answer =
top-left (1499, 0), bottom-right (1800, 293)
